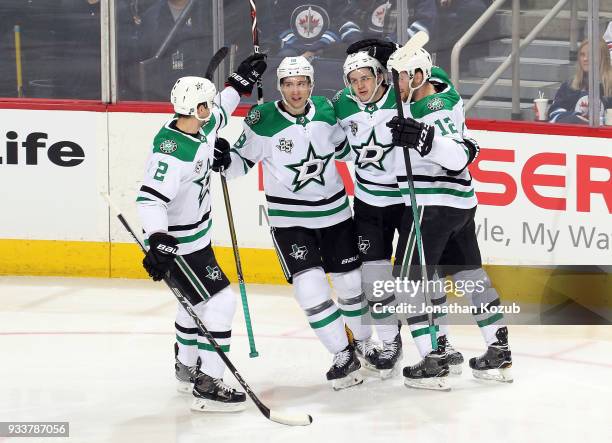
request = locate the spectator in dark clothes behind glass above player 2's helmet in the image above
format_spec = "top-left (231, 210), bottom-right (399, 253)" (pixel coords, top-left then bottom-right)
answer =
top-left (137, 0), bottom-right (214, 101)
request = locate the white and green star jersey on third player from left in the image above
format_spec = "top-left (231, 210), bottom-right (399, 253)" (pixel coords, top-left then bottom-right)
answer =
top-left (332, 88), bottom-right (405, 207)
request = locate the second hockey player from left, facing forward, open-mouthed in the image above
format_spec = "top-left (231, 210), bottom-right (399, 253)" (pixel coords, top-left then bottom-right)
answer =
top-left (215, 56), bottom-right (369, 390)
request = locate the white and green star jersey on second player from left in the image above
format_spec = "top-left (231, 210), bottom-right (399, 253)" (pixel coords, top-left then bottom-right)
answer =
top-left (226, 97), bottom-right (351, 228)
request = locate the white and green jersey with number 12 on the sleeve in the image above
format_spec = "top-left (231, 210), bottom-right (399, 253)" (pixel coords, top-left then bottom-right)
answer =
top-left (395, 66), bottom-right (478, 209)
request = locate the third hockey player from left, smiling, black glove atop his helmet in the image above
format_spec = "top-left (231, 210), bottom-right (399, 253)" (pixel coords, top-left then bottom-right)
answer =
top-left (333, 44), bottom-right (463, 378)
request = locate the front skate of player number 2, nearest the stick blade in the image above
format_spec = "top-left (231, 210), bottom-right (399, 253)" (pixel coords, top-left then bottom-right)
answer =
top-left (191, 372), bottom-right (246, 412)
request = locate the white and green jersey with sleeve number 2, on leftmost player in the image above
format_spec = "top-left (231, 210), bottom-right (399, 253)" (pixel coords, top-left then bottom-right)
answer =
top-left (136, 87), bottom-right (240, 255)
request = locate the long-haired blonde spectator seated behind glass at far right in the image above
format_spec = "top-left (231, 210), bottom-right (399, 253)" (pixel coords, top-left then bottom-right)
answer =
top-left (548, 39), bottom-right (612, 124)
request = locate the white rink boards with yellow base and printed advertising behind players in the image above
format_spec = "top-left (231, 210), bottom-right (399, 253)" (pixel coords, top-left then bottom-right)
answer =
top-left (0, 105), bottom-right (612, 294)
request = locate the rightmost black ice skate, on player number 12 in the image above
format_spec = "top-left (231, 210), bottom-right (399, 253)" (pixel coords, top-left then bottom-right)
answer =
top-left (470, 326), bottom-right (514, 383)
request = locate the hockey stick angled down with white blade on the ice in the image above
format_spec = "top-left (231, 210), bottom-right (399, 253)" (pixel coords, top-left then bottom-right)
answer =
top-left (101, 193), bottom-right (312, 426)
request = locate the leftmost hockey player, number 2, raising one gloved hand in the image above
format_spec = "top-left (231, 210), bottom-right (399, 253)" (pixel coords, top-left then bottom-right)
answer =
top-left (136, 55), bottom-right (266, 412)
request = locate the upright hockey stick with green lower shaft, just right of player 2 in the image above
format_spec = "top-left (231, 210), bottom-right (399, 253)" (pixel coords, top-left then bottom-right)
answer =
top-left (205, 46), bottom-right (259, 358)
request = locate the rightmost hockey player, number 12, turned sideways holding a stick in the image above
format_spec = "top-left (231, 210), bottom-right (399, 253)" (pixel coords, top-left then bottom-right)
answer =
top-left (387, 48), bottom-right (512, 390)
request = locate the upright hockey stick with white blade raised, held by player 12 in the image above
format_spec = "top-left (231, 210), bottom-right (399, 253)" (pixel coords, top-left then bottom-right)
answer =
top-left (392, 31), bottom-right (438, 350)
